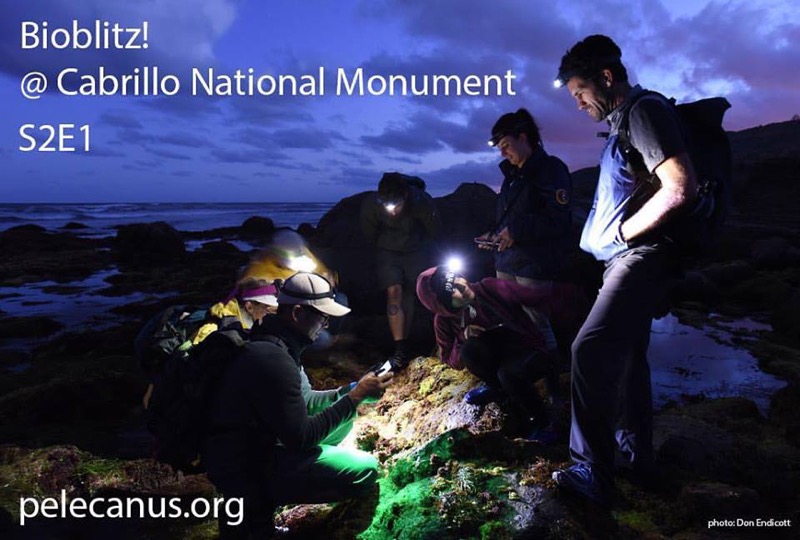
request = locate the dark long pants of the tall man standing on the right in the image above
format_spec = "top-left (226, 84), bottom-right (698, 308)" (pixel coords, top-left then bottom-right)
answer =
top-left (570, 246), bottom-right (674, 487)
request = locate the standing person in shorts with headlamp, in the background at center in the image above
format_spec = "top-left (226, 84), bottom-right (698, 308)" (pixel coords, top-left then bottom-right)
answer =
top-left (361, 172), bottom-right (439, 372)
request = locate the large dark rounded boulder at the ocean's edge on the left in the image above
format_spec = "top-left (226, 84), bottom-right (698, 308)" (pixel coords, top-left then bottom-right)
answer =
top-left (114, 221), bottom-right (186, 264)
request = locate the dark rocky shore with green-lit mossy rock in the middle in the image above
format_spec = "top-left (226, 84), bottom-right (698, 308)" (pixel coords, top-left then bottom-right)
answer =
top-left (0, 122), bottom-right (800, 540)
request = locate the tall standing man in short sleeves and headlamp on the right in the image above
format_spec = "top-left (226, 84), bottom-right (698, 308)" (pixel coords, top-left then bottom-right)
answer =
top-left (553, 35), bottom-right (697, 506)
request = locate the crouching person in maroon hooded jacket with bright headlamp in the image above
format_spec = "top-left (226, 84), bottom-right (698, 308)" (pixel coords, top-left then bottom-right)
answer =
top-left (417, 266), bottom-right (586, 443)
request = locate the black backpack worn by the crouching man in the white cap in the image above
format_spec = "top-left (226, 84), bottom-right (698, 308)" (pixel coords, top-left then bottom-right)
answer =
top-left (147, 327), bottom-right (246, 473)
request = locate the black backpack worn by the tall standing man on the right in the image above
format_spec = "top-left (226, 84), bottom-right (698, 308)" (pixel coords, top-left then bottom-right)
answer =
top-left (617, 91), bottom-right (733, 256)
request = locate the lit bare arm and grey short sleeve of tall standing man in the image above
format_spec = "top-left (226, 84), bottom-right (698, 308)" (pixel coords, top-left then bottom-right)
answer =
top-left (619, 97), bottom-right (697, 242)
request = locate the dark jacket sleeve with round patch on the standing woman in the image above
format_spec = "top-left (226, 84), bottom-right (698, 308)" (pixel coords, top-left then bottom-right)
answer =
top-left (508, 156), bottom-right (572, 245)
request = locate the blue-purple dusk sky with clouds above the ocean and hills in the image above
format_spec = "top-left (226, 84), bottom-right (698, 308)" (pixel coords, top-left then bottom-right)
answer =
top-left (0, 0), bottom-right (800, 202)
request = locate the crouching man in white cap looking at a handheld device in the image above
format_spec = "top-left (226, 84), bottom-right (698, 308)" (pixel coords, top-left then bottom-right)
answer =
top-left (203, 273), bottom-right (391, 539)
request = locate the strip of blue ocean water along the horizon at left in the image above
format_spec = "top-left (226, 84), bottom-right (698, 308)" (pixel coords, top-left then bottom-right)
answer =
top-left (0, 203), bottom-right (335, 237)
